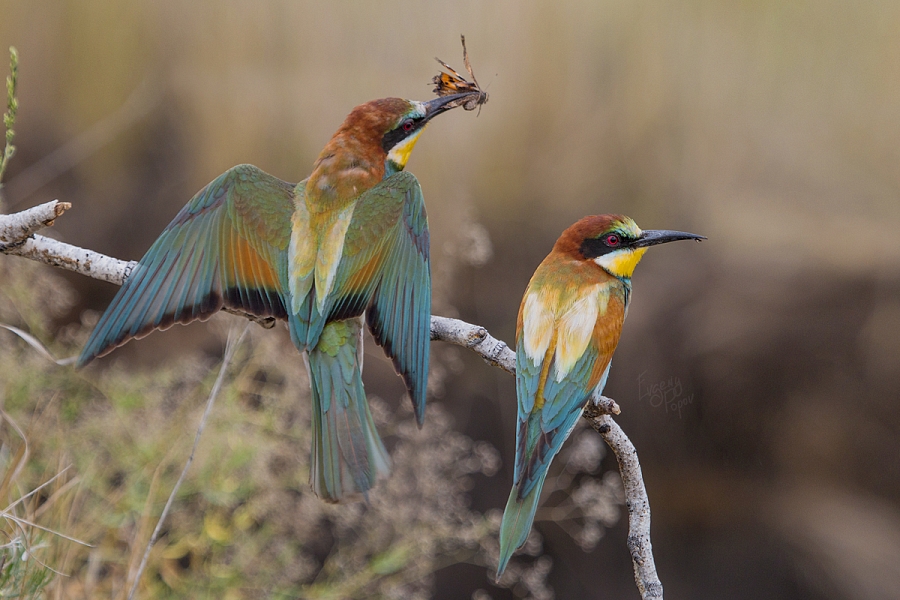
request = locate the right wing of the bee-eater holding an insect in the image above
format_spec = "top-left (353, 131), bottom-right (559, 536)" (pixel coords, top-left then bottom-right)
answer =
top-left (324, 172), bottom-right (431, 423)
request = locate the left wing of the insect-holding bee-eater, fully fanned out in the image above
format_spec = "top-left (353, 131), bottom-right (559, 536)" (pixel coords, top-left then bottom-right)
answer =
top-left (78, 165), bottom-right (294, 365)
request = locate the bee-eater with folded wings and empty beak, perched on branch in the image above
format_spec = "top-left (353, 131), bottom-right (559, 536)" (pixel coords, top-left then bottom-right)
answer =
top-left (497, 215), bottom-right (706, 579)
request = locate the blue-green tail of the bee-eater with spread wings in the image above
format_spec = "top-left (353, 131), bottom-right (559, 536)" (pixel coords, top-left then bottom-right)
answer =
top-left (309, 319), bottom-right (390, 502)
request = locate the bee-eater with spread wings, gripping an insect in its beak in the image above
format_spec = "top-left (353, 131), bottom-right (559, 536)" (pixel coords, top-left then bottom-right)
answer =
top-left (77, 89), bottom-right (482, 501)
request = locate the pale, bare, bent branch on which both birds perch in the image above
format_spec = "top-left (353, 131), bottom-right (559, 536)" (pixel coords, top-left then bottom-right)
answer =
top-left (0, 201), bottom-right (663, 600)
